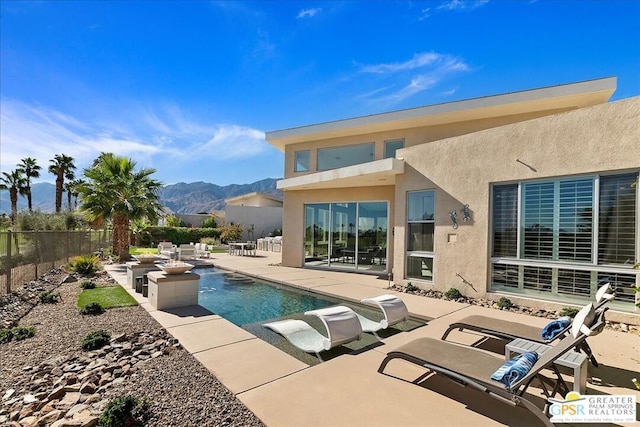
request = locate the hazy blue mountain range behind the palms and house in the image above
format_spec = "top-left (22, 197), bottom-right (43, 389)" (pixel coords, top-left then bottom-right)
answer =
top-left (0, 178), bottom-right (282, 214)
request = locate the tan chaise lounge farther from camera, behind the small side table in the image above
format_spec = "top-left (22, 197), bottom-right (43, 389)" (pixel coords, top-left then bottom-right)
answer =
top-left (441, 283), bottom-right (615, 367)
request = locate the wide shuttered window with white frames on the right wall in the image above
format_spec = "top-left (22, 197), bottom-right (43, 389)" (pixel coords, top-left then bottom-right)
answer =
top-left (491, 173), bottom-right (638, 302)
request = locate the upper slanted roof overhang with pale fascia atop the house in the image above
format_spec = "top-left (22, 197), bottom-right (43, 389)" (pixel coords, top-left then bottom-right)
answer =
top-left (265, 77), bottom-right (617, 152)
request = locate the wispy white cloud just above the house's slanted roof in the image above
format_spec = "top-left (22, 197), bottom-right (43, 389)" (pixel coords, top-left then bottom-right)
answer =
top-left (361, 52), bottom-right (470, 104)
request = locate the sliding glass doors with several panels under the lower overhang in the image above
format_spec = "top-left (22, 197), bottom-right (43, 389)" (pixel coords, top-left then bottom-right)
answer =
top-left (304, 202), bottom-right (389, 272)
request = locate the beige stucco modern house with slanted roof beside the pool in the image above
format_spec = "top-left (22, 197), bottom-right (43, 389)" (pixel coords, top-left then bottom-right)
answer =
top-left (266, 77), bottom-right (640, 312)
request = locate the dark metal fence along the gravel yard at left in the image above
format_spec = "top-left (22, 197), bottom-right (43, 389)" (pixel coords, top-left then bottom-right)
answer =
top-left (0, 230), bottom-right (111, 295)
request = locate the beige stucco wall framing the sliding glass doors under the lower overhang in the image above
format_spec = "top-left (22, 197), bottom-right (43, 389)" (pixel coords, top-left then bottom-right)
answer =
top-left (282, 186), bottom-right (394, 267)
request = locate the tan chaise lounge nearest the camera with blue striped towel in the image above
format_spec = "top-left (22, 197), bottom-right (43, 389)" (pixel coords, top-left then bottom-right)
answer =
top-left (378, 304), bottom-right (606, 427)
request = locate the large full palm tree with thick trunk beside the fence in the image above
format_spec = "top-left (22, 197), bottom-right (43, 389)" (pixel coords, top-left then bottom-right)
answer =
top-left (78, 153), bottom-right (162, 262)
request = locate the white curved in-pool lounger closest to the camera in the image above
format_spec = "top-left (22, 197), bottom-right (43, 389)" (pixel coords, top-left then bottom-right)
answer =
top-left (262, 305), bottom-right (362, 361)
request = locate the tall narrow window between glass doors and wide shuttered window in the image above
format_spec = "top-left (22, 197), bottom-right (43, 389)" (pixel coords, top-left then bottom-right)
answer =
top-left (406, 191), bottom-right (435, 280)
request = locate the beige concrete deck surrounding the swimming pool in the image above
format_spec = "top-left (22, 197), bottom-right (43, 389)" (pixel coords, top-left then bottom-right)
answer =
top-left (106, 251), bottom-right (640, 427)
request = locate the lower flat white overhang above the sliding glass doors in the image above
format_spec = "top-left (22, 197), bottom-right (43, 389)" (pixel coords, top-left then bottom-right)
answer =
top-left (277, 158), bottom-right (404, 191)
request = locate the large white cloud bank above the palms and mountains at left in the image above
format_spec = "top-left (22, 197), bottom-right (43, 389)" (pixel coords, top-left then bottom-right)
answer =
top-left (0, 98), bottom-right (268, 180)
